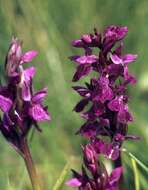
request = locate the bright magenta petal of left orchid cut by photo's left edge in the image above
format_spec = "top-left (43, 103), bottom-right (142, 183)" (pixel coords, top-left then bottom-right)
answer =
top-left (0, 95), bottom-right (12, 112)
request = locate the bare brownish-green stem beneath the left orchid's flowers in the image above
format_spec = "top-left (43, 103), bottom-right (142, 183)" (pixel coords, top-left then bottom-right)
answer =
top-left (21, 139), bottom-right (41, 190)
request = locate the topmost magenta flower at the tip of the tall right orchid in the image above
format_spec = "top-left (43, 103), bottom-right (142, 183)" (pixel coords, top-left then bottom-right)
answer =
top-left (104, 25), bottom-right (128, 40)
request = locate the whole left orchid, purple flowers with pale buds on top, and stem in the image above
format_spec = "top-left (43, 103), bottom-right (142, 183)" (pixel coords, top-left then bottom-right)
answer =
top-left (0, 38), bottom-right (50, 189)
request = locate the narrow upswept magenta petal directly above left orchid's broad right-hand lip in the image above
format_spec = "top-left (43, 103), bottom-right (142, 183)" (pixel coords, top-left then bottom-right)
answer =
top-left (32, 88), bottom-right (47, 103)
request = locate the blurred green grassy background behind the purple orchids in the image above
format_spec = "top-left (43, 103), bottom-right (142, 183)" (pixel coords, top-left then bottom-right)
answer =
top-left (0, 0), bottom-right (148, 190)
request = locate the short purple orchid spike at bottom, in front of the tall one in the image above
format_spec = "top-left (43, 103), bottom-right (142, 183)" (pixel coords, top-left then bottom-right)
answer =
top-left (66, 144), bottom-right (123, 190)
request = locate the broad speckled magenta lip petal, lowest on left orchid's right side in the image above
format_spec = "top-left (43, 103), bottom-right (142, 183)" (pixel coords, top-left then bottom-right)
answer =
top-left (29, 104), bottom-right (50, 121)
